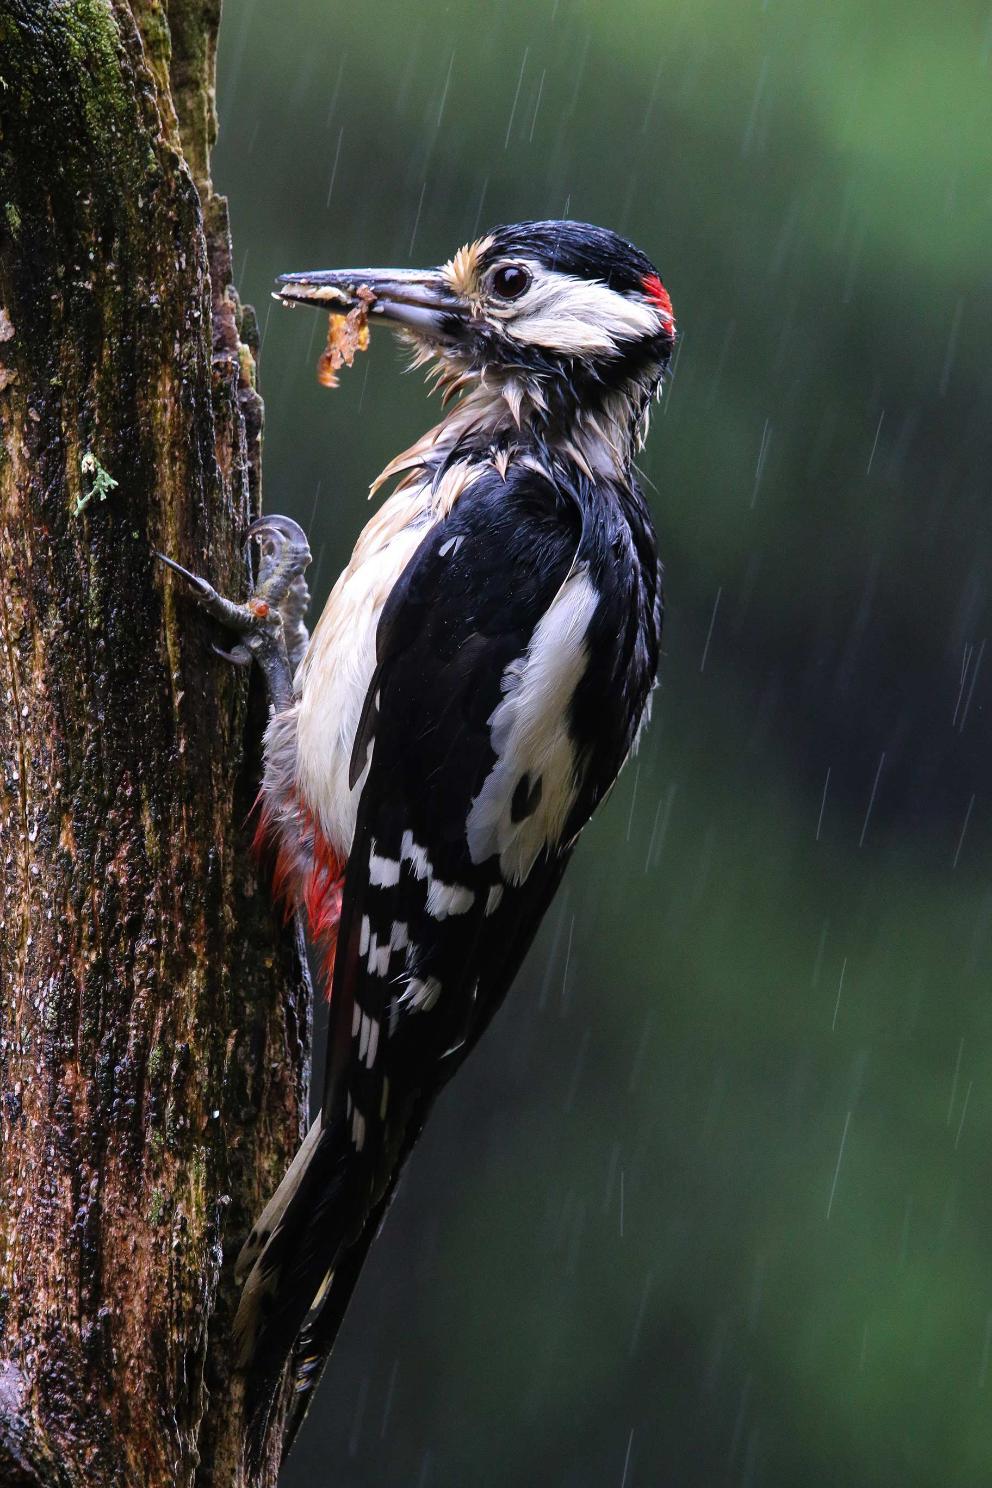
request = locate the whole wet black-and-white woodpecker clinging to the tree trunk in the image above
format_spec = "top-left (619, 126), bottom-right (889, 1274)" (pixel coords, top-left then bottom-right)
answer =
top-left (167, 222), bottom-right (675, 1446)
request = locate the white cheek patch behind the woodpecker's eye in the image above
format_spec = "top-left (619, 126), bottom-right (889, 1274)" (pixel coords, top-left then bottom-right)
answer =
top-left (501, 263), bottom-right (662, 356)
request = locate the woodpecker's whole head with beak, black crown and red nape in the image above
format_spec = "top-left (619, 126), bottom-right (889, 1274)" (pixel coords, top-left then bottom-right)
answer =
top-left (278, 222), bottom-right (675, 464)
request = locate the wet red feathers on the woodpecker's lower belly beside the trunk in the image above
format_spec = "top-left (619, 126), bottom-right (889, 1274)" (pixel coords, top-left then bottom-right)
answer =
top-left (251, 796), bottom-right (345, 1001)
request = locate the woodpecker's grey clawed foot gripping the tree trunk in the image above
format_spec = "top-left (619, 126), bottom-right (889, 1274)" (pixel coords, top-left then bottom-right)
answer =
top-left (156, 516), bottom-right (311, 711)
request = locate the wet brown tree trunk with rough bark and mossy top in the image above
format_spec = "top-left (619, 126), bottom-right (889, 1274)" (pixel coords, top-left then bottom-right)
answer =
top-left (0, 0), bottom-right (311, 1488)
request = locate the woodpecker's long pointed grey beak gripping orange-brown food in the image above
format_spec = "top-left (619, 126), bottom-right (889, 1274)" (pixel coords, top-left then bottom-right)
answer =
top-left (274, 269), bottom-right (466, 338)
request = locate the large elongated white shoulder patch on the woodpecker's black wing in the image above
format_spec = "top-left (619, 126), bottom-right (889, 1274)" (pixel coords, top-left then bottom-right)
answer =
top-left (466, 568), bottom-right (599, 874)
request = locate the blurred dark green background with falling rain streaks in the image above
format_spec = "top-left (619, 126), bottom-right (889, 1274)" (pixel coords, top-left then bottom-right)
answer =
top-left (214, 0), bottom-right (992, 1488)
